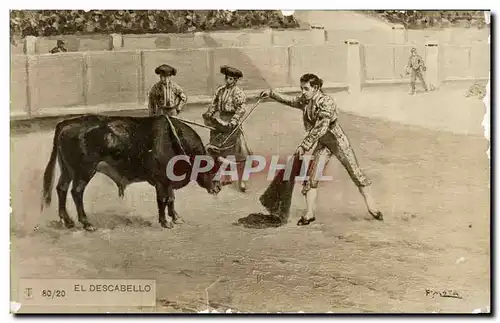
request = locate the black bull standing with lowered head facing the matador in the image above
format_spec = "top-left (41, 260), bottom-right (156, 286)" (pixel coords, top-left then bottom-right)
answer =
top-left (42, 115), bottom-right (232, 231)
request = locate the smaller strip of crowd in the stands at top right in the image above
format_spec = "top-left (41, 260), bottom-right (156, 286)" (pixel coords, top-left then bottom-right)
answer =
top-left (375, 10), bottom-right (485, 29)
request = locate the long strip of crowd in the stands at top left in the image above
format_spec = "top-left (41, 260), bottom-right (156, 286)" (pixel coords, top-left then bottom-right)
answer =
top-left (10, 10), bottom-right (299, 37)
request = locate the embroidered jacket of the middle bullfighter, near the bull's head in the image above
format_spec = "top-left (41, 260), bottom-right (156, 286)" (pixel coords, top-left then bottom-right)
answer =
top-left (205, 85), bottom-right (247, 124)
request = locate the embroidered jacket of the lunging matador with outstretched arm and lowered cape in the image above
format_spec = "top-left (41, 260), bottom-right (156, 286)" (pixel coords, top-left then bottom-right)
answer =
top-left (270, 91), bottom-right (340, 151)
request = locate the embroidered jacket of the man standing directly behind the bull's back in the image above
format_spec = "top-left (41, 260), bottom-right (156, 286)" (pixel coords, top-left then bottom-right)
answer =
top-left (149, 81), bottom-right (187, 115)
